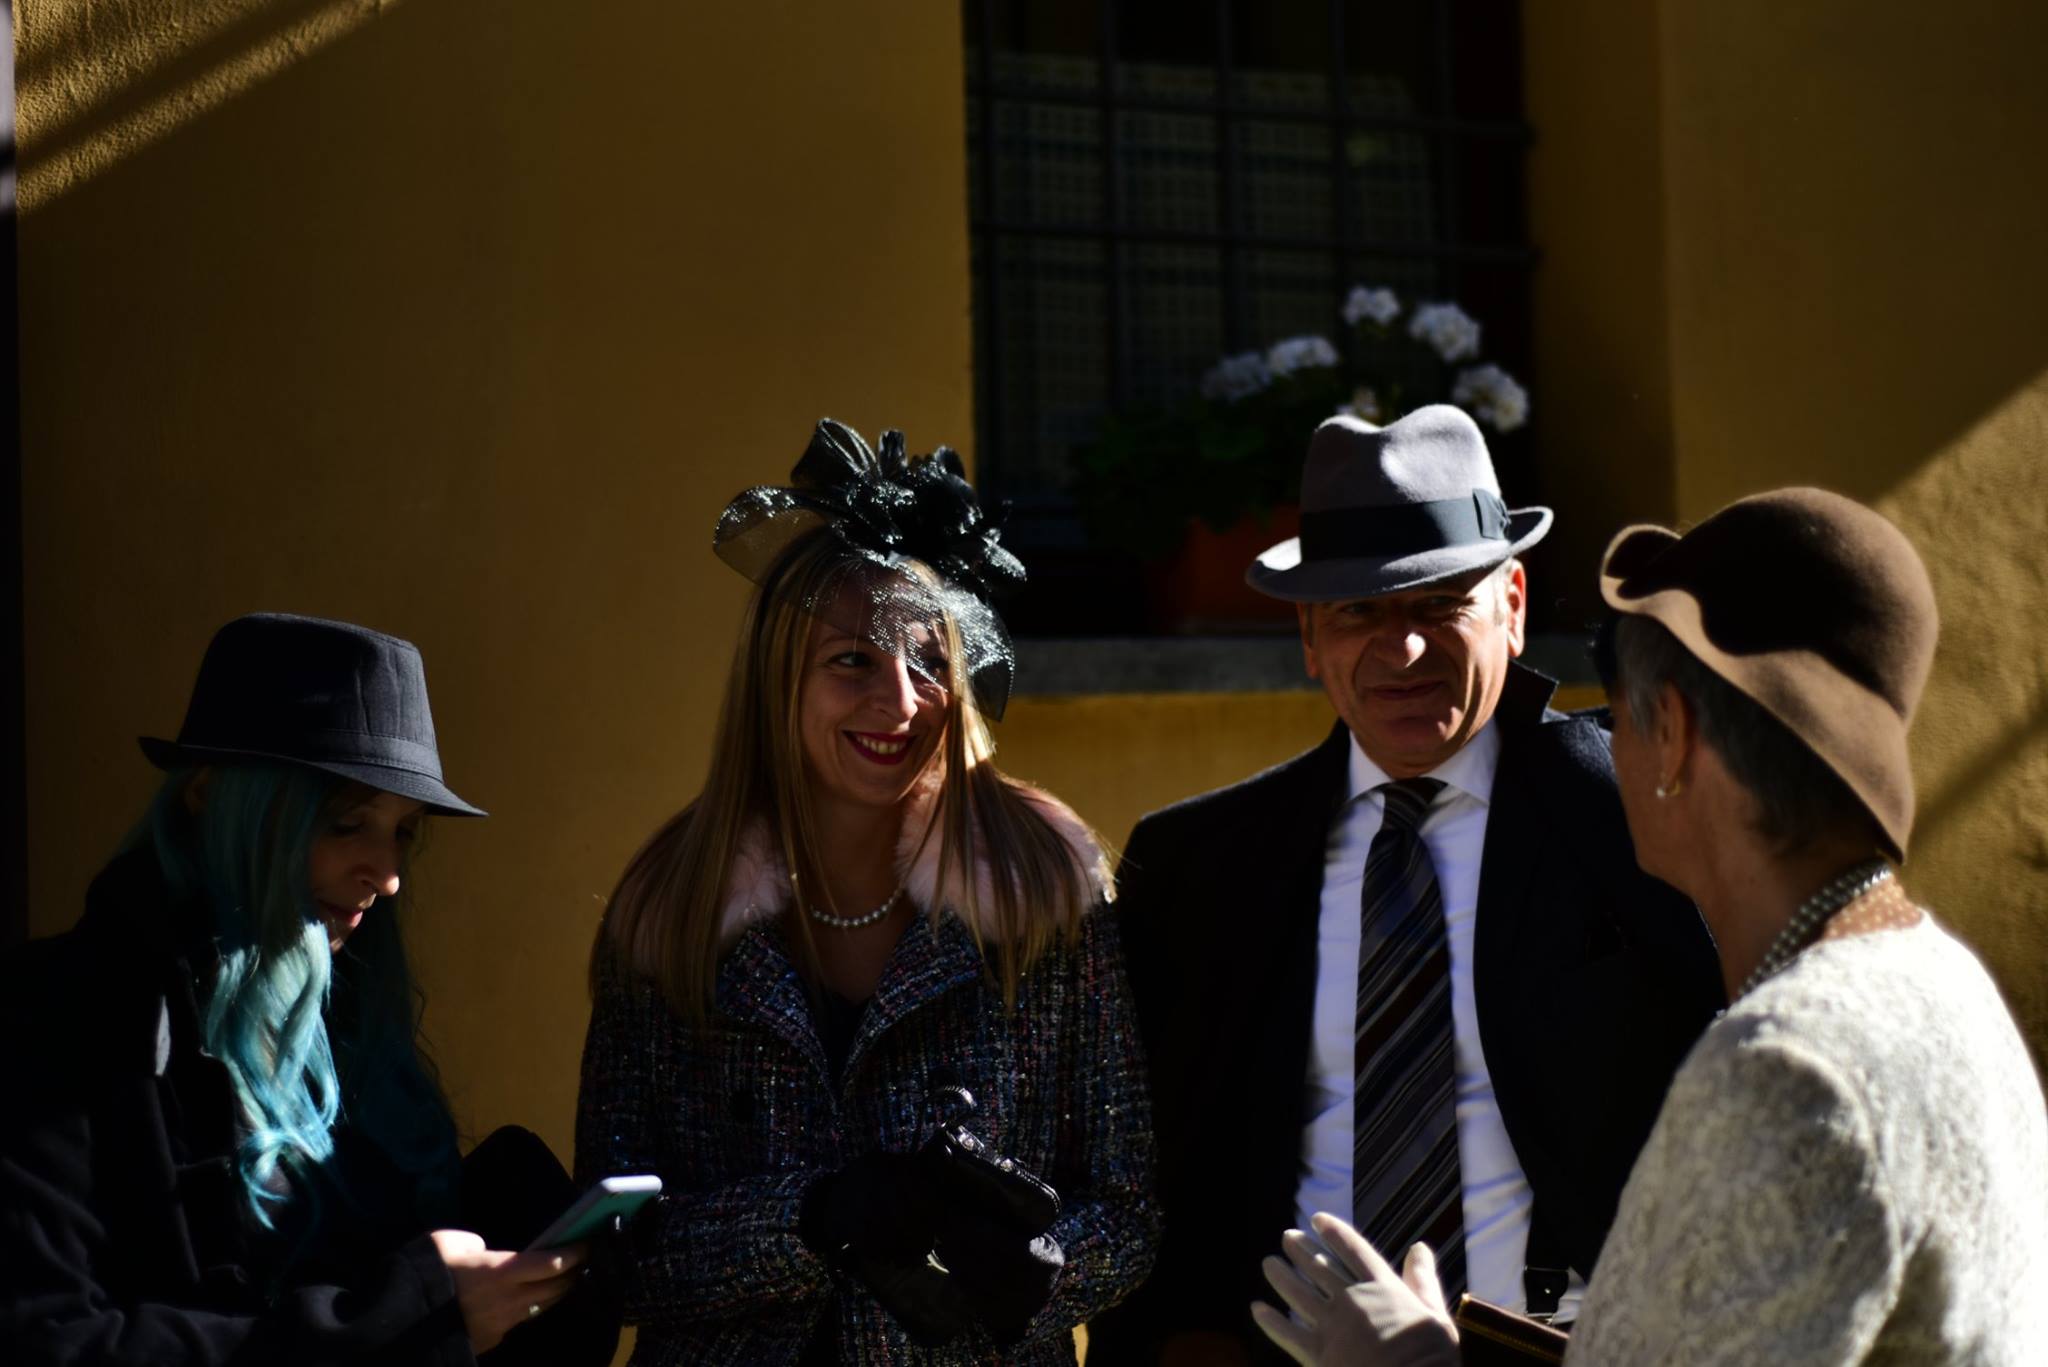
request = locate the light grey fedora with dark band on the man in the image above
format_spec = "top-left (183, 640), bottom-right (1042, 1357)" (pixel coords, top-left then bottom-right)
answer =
top-left (1245, 404), bottom-right (1550, 603)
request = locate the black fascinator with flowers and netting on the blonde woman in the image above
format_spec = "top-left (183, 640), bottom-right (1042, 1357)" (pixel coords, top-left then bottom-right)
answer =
top-left (711, 418), bottom-right (1024, 719)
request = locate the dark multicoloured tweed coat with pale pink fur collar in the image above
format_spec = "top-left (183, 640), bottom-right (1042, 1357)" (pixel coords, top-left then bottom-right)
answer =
top-left (575, 797), bottom-right (1159, 1367)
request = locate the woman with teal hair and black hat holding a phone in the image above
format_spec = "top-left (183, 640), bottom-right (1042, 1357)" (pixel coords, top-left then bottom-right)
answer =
top-left (0, 615), bottom-right (614, 1367)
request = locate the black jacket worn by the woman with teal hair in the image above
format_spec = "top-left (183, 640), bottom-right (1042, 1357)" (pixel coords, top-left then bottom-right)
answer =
top-left (0, 853), bottom-right (616, 1367)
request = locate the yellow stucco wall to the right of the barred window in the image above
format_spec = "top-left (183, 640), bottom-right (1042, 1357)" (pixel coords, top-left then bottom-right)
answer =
top-left (1526, 0), bottom-right (2048, 1058)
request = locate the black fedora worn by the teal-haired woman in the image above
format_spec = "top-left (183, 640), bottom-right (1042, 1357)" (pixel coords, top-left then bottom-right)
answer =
top-left (141, 613), bottom-right (483, 816)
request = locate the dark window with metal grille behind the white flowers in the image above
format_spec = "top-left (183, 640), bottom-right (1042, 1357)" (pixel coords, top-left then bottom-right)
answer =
top-left (963, 0), bottom-right (1534, 635)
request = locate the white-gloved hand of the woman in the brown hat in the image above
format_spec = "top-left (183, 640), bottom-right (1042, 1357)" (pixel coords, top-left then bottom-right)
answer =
top-left (1251, 1213), bottom-right (1458, 1367)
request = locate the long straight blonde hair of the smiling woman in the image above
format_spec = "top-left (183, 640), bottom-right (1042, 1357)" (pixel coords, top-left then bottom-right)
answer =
top-left (592, 531), bottom-right (1096, 1025)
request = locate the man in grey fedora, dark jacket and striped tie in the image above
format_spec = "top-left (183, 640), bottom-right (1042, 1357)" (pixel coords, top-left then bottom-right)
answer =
top-left (1090, 406), bottom-right (1720, 1363)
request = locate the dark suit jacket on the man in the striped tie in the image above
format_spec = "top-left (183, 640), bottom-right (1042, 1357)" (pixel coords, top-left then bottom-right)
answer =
top-left (1090, 666), bottom-right (1722, 1363)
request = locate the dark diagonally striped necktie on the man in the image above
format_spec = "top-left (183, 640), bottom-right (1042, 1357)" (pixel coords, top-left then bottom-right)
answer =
top-left (1352, 779), bottom-right (1464, 1299)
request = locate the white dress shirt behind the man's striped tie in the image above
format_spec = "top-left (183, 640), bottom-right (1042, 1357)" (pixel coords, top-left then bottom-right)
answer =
top-left (1294, 721), bottom-right (1583, 1320)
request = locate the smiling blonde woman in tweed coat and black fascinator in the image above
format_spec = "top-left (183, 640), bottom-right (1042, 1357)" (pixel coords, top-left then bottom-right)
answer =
top-left (578, 420), bottom-right (1157, 1363)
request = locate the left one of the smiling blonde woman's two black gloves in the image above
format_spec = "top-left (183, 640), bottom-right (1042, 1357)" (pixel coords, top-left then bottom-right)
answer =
top-left (797, 1154), bottom-right (975, 1349)
